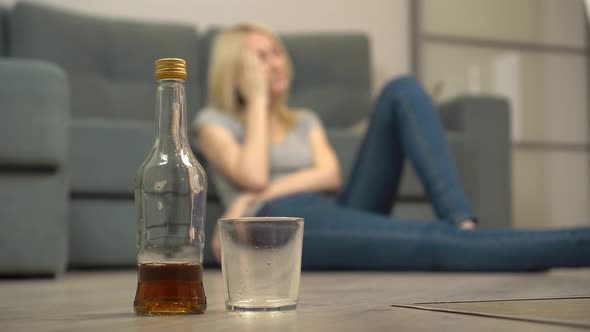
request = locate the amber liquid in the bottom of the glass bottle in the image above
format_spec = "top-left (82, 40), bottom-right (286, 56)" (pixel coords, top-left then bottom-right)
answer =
top-left (133, 263), bottom-right (207, 315)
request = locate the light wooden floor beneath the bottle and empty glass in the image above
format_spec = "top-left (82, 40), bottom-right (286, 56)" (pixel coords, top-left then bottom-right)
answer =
top-left (0, 269), bottom-right (590, 332)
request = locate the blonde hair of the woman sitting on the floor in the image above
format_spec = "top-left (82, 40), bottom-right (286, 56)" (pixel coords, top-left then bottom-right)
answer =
top-left (207, 22), bottom-right (295, 128)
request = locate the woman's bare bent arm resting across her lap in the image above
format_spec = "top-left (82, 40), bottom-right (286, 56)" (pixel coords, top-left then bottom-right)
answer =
top-left (258, 126), bottom-right (342, 201)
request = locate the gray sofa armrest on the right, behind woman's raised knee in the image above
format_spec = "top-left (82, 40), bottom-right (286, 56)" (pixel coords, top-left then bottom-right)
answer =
top-left (439, 96), bottom-right (512, 227)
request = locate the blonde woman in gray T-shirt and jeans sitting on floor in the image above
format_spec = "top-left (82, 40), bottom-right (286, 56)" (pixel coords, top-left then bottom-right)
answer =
top-left (194, 23), bottom-right (590, 271)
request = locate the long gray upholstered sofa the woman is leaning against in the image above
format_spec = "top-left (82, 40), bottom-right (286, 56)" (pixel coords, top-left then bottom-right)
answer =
top-left (0, 2), bottom-right (511, 273)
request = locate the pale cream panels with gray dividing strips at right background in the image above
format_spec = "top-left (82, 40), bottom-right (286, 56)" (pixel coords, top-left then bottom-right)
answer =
top-left (422, 0), bottom-right (590, 227)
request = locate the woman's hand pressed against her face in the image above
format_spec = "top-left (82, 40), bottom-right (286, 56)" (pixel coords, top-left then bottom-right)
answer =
top-left (238, 49), bottom-right (269, 105)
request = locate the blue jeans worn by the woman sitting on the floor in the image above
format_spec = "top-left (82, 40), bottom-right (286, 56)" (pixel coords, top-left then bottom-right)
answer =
top-left (259, 78), bottom-right (590, 271)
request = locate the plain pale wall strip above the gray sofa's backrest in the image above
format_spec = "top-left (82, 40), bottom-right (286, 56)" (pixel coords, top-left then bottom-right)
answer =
top-left (0, 0), bottom-right (411, 87)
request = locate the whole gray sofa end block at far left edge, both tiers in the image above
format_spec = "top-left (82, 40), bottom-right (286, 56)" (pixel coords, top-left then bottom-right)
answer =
top-left (0, 59), bottom-right (70, 275)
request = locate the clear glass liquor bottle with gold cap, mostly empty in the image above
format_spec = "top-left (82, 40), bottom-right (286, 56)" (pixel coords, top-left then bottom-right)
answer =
top-left (133, 58), bottom-right (207, 315)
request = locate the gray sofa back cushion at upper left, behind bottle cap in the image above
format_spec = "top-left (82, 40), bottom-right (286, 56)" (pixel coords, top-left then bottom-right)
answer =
top-left (10, 1), bottom-right (199, 120)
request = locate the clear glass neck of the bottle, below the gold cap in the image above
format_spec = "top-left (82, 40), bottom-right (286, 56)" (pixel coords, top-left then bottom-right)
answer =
top-left (156, 79), bottom-right (188, 151)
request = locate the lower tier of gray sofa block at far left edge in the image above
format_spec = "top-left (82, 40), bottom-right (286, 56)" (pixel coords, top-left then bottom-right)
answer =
top-left (0, 171), bottom-right (68, 275)
